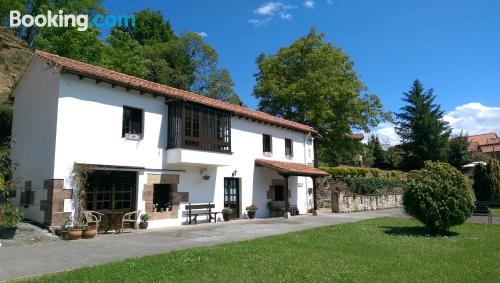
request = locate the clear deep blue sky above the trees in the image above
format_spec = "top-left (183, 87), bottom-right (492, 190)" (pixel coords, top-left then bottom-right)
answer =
top-left (104, 0), bottom-right (500, 144)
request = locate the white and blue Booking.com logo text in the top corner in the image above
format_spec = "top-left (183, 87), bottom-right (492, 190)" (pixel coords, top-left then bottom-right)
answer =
top-left (9, 10), bottom-right (135, 31)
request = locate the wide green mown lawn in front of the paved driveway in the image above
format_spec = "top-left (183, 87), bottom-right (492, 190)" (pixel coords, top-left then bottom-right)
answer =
top-left (20, 218), bottom-right (500, 282)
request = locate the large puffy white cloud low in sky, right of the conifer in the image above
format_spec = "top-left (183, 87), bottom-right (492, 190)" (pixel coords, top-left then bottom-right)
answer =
top-left (444, 102), bottom-right (500, 135)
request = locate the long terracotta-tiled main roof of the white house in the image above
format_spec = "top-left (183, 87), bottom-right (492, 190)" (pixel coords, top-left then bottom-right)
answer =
top-left (35, 50), bottom-right (317, 135)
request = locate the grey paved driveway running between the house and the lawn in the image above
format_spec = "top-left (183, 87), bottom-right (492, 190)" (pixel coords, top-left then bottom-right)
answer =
top-left (0, 209), bottom-right (404, 281)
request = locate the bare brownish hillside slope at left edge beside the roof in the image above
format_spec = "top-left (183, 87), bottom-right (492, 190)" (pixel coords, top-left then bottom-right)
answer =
top-left (0, 28), bottom-right (31, 105)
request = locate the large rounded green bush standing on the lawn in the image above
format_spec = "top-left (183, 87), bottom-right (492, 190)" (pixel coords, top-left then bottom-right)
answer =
top-left (403, 161), bottom-right (474, 234)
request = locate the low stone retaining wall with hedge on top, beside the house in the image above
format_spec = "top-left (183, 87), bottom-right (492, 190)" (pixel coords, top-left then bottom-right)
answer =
top-left (331, 191), bottom-right (403, 212)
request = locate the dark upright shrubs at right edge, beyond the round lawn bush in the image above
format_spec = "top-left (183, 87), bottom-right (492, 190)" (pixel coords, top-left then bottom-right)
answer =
top-left (474, 159), bottom-right (500, 200)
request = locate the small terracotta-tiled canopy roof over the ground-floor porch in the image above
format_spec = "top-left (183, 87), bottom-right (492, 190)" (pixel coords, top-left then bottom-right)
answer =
top-left (255, 159), bottom-right (329, 177)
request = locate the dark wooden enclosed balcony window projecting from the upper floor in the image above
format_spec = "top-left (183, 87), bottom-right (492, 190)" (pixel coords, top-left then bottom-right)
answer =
top-left (168, 103), bottom-right (231, 152)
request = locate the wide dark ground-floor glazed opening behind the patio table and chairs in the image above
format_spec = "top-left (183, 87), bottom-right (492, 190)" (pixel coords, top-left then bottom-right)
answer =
top-left (85, 170), bottom-right (137, 211)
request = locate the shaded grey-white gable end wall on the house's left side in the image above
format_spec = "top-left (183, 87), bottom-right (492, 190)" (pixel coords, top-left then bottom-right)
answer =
top-left (11, 59), bottom-right (59, 222)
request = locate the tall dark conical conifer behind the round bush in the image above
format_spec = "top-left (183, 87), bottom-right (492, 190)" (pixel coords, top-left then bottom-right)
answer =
top-left (396, 80), bottom-right (451, 169)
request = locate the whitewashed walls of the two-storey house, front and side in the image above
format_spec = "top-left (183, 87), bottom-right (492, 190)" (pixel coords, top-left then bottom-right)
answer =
top-left (13, 61), bottom-right (314, 227)
